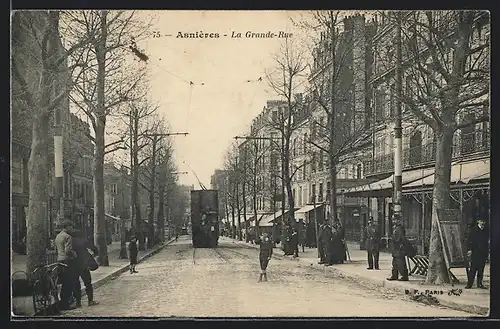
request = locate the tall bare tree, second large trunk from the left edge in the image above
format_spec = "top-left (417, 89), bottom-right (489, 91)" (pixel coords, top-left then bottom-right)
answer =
top-left (67, 10), bottom-right (147, 266)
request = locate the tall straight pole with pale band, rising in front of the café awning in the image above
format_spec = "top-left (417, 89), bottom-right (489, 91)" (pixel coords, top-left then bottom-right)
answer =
top-left (393, 12), bottom-right (403, 219)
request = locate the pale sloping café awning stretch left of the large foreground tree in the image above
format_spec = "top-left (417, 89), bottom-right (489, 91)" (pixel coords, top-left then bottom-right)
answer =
top-left (344, 167), bottom-right (434, 196)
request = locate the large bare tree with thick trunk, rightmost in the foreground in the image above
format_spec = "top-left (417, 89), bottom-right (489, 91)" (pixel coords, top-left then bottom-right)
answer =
top-left (387, 11), bottom-right (490, 284)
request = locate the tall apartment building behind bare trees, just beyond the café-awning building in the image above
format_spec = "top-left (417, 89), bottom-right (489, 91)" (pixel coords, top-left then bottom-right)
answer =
top-left (294, 15), bottom-right (375, 240)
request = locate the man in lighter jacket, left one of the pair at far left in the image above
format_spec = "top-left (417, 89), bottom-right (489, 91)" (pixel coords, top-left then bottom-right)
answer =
top-left (54, 219), bottom-right (78, 310)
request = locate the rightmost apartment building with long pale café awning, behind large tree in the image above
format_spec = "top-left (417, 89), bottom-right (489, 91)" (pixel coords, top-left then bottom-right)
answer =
top-left (347, 11), bottom-right (490, 253)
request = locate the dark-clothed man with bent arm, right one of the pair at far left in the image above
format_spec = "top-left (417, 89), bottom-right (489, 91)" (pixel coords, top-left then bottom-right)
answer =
top-left (72, 231), bottom-right (99, 307)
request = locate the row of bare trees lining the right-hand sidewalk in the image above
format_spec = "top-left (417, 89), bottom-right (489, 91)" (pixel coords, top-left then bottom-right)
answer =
top-left (214, 11), bottom-right (490, 284)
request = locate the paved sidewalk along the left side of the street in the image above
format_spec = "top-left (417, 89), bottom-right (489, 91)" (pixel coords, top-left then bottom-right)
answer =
top-left (12, 239), bottom-right (175, 316)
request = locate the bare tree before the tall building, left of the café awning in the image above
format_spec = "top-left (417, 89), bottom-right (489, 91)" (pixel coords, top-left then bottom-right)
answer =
top-left (296, 11), bottom-right (370, 217)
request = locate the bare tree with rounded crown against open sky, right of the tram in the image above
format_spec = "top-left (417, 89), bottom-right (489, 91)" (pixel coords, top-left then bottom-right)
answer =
top-left (266, 39), bottom-right (307, 223)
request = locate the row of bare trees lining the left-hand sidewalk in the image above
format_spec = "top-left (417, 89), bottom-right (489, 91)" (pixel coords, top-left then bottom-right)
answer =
top-left (11, 10), bottom-right (189, 271)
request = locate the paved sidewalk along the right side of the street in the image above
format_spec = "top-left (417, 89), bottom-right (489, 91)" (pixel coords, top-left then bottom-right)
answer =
top-left (223, 237), bottom-right (490, 315)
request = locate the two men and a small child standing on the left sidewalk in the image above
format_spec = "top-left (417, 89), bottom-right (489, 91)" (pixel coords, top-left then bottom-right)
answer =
top-left (54, 220), bottom-right (138, 310)
